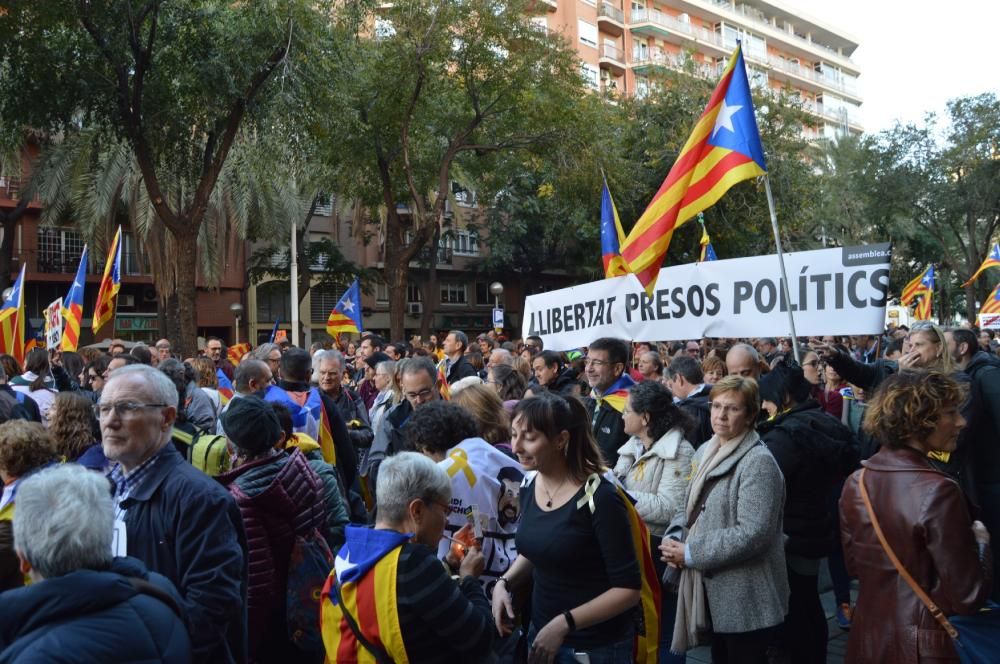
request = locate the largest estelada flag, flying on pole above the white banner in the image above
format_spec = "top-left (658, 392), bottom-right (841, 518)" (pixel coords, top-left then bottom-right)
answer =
top-left (622, 46), bottom-right (767, 293)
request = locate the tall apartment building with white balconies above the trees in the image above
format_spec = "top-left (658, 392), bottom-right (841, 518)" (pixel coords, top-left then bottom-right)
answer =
top-left (532, 0), bottom-right (863, 138)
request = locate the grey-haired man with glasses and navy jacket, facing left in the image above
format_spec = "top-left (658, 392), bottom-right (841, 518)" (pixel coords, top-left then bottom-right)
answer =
top-left (98, 364), bottom-right (247, 664)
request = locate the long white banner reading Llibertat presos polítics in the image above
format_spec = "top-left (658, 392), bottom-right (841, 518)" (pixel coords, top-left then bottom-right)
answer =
top-left (521, 243), bottom-right (892, 350)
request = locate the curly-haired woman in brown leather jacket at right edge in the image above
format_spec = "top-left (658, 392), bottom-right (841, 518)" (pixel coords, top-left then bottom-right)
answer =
top-left (840, 370), bottom-right (992, 664)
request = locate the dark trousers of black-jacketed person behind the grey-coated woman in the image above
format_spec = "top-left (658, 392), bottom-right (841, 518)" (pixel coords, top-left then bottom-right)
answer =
top-left (777, 567), bottom-right (828, 664)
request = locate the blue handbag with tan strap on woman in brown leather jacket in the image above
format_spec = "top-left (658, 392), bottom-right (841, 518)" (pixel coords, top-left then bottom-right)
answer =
top-left (858, 468), bottom-right (1000, 664)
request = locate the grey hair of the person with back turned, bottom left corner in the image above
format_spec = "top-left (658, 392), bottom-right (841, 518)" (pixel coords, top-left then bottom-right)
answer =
top-left (14, 464), bottom-right (113, 579)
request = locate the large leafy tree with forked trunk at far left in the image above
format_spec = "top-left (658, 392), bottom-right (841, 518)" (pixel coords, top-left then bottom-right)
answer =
top-left (0, 0), bottom-right (363, 352)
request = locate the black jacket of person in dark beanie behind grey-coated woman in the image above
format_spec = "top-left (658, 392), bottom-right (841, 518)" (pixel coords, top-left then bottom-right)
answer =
top-left (757, 399), bottom-right (858, 558)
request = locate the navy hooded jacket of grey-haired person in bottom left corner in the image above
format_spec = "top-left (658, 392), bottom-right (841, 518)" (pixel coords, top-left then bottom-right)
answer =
top-left (0, 558), bottom-right (191, 664)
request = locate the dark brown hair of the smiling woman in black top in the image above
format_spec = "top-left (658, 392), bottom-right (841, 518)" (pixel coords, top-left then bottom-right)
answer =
top-left (512, 392), bottom-right (607, 482)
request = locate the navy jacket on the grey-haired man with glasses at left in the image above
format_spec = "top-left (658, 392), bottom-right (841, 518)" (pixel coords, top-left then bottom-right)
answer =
top-left (116, 445), bottom-right (247, 664)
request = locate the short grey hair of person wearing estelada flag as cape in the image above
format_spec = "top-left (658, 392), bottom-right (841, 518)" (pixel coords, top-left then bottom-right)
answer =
top-left (376, 452), bottom-right (451, 524)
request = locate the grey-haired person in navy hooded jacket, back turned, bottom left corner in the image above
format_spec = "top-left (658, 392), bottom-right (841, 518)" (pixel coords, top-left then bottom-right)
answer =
top-left (0, 464), bottom-right (191, 664)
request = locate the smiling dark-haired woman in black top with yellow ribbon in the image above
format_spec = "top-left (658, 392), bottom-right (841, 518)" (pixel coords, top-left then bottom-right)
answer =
top-left (493, 393), bottom-right (641, 664)
